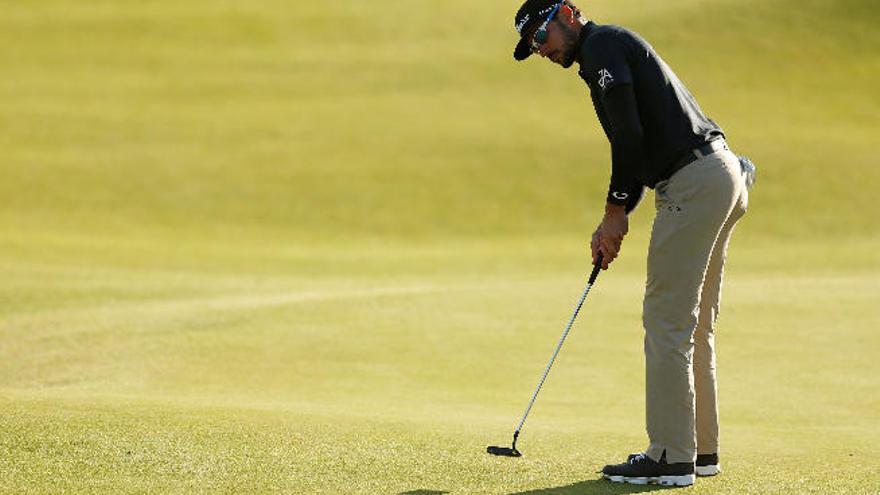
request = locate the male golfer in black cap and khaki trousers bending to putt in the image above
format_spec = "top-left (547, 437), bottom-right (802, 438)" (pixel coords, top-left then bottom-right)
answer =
top-left (514, 0), bottom-right (754, 485)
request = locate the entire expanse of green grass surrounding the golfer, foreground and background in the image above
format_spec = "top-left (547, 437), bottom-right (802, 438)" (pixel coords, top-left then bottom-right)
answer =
top-left (0, 0), bottom-right (880, 495)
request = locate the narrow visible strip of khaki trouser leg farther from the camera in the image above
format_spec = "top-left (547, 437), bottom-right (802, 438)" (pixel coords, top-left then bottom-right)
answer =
top-left (693, 172), bottom-right (748, 454)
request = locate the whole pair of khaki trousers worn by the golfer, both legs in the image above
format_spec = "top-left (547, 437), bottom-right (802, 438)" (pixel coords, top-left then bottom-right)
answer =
top-left (642, 144), bottom-right (748, 463)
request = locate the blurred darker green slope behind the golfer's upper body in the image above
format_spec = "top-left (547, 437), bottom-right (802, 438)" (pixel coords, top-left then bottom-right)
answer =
top-left (0, 0), bottom-right (880, 244)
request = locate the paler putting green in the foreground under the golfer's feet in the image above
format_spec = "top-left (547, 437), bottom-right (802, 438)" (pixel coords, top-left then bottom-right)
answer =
top-left (0, 236), bottom-right (880, 493)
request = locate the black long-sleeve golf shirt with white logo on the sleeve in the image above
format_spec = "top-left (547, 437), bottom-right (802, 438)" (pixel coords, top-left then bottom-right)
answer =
top-left (577, 22), bottom-right (724, 208)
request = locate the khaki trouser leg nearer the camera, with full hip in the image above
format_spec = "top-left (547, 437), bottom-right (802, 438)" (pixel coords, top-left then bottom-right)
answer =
top-left (643, 151), bottom-right (744, 462)
